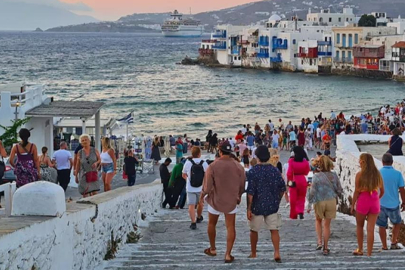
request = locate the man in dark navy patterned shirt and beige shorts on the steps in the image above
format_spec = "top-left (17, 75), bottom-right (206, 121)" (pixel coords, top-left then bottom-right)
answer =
top-left (247, 145), bottom-right (286, 263)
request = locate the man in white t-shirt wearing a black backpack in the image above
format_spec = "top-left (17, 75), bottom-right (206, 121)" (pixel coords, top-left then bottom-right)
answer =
top-left (183, 146), bottom-right (208, 230)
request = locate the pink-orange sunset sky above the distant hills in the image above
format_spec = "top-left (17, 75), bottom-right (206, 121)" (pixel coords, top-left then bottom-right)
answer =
top-left (61, 0), bottom-right (260, 20)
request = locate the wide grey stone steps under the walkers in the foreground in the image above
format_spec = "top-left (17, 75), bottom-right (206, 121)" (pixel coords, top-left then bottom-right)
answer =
top-left (104, 200), bottom-right (405, 270)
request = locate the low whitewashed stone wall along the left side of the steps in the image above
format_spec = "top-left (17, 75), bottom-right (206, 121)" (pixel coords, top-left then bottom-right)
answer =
top-left (0, 182), bottom-right (162, 270)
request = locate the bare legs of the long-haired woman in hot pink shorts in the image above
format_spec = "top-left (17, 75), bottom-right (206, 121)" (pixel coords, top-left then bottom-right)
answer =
top-left (356, 213), bottom-right (378, 256)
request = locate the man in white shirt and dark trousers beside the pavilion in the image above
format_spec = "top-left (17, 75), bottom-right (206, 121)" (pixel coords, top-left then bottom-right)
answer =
top-left (52, 141), bottom-right (73, 192)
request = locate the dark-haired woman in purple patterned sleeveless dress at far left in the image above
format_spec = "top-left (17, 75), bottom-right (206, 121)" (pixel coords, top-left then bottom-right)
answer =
top-left (10, 128), bottom-right (41, 187)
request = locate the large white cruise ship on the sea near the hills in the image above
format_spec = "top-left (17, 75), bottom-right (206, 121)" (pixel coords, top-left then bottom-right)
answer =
top-left (162, 10), bottom-right (204, 37)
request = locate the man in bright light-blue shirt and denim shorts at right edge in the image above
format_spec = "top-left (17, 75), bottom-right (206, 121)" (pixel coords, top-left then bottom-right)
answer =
top-left (377, 153), bottom-right (405, 250)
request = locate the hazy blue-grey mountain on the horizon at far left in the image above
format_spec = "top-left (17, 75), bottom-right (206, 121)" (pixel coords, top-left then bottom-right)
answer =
top-left (0, 0), bottom-right (98, 31)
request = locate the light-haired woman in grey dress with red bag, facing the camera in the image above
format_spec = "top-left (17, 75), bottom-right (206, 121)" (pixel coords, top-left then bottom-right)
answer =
top-left (75, 134), bottom-right (101, 197)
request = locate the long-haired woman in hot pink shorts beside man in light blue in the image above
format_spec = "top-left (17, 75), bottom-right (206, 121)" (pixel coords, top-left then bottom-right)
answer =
top-left (351, 153), bottom-right (384, 256)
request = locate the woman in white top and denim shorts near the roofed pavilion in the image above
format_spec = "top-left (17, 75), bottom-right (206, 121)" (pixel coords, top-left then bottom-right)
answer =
top-left (100, 137), bottom-right (117, 192)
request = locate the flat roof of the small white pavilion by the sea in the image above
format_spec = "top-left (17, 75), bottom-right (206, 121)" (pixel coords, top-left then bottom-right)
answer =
top-left (25, 100), bottom-right (104, 117)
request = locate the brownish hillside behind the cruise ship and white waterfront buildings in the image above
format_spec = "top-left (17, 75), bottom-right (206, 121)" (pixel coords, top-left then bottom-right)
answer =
top-left (43, 0), bottom-right (405, 32)
